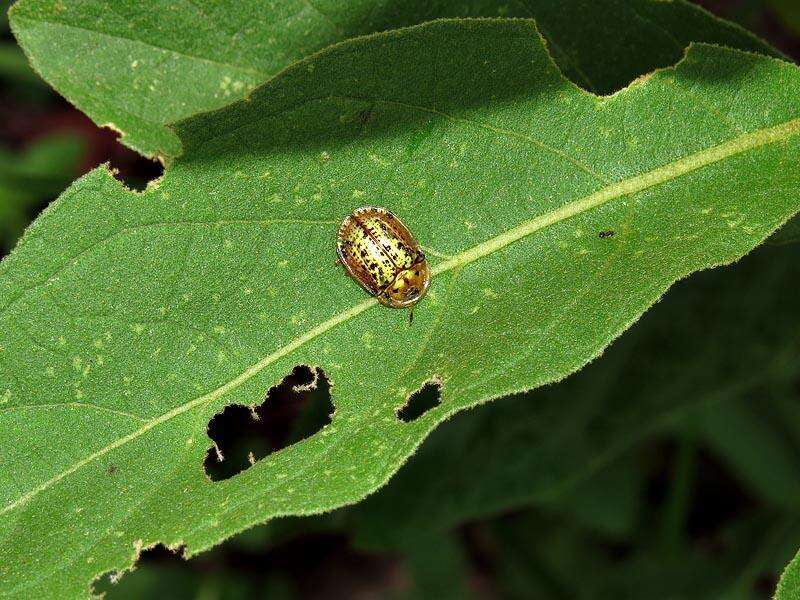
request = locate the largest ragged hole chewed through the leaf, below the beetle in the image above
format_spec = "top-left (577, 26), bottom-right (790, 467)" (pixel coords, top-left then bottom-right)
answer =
top-left (204, 365), bottom-right (334, 481)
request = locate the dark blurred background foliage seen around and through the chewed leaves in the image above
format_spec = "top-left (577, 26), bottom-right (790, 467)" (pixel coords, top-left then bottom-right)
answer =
top-left (0, 0), bottom-right (800, 599)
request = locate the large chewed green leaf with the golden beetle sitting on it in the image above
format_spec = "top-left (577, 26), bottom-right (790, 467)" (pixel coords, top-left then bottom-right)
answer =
top-left (0, 20), bottom-right (800, 597)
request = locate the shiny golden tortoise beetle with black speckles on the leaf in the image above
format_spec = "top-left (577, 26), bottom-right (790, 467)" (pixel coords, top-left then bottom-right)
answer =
top-left (336, 206), bottom-right (431, 318)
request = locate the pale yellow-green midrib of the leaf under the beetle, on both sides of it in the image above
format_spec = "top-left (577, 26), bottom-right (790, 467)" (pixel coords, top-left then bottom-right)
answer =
top-left (0, 118), bottom-right (800, 515)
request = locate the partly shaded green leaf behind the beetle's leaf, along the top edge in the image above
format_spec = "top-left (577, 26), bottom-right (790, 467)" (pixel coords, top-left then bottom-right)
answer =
top-left (12, 0), bottom-right (775, 157)
